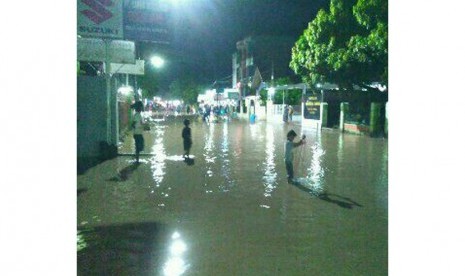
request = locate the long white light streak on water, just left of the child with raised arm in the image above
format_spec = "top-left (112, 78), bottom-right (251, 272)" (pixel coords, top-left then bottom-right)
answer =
top-left (263, 124), bottom-right (278, 197)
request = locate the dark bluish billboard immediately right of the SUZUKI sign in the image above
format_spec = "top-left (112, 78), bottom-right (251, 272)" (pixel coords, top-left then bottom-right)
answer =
top-left (123, 0), bottom-right (170, 44)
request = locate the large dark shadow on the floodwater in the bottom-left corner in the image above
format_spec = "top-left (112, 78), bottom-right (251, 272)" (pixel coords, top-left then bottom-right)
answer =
top-left (77, 222), bottom-right (169, 276)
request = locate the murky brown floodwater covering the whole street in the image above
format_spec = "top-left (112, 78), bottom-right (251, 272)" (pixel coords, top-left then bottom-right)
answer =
top-left (77, 117), bottom-right (388, 276)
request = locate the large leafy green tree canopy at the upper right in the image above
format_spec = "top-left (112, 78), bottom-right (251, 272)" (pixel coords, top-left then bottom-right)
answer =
top-left (289, 0), bottom-right (388, 88)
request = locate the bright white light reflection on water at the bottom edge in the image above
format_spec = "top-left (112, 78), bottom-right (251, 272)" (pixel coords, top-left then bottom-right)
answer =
top-left (163, 231), bottom-right (189, 276)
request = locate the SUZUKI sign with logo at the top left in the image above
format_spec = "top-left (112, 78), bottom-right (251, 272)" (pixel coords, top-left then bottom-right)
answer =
top-left (77, 0), bottom-right (123, 39)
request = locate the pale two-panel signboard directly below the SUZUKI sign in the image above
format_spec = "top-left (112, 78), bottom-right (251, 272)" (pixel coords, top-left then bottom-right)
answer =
top-left (77, 38), bottom-right (136, 64)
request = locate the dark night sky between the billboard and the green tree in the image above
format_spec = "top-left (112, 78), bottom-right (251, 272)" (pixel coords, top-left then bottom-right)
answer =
top-left (139, 0), bottom-right (329, 90)
